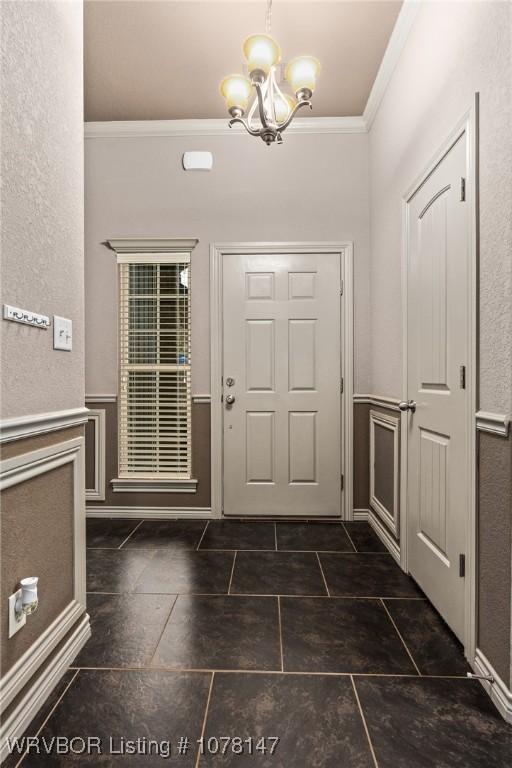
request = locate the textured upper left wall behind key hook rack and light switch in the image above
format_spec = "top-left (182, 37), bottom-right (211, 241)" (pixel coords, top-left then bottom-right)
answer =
top-left (0, 0), bottom-right (84, 418)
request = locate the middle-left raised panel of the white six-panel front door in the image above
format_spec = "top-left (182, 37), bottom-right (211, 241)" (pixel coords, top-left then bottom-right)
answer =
top-left (245, 320), bottom-right (275, 392)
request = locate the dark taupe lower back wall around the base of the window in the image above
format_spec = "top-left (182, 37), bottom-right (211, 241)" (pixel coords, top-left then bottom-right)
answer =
top-left (86, 399), bottom-right (211, 511)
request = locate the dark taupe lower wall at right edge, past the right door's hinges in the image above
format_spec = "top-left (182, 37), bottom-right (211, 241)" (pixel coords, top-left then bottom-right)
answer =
top-left (477, 432), bottom-right (512, 686)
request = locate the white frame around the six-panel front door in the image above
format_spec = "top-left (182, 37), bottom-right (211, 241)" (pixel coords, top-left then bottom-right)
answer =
top-left (210, 241), bottom-right (354, 520)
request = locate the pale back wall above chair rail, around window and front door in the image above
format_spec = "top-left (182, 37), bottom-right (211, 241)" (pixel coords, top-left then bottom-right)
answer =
top-left (85, 134), bottom-right (369, 394)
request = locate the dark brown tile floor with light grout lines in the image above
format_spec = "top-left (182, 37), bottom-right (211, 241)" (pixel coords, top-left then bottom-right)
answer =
top-left (6, 519), bottom-right (512, 768)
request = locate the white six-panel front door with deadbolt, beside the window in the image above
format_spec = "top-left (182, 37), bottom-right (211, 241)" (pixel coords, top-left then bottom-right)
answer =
top-left (222, 253), bottom-right (341, 517)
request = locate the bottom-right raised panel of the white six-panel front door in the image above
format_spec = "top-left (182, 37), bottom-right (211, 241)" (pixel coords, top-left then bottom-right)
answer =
top-left (288, 411), bottom-right (317, 483)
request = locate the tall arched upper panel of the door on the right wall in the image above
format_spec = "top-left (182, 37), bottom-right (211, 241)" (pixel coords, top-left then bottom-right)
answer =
top-left (419, 191), bottom-right (448, 389)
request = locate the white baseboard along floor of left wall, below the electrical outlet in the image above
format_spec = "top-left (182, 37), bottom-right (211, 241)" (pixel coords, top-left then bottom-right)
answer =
top-left (0, 614), bottom-right (91, 762)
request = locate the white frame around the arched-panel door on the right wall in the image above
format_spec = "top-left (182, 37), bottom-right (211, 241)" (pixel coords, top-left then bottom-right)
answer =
top-left (400, 99), bottom-right (478, 661)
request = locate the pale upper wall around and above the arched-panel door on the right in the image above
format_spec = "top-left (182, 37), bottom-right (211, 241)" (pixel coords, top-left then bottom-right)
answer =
top-left (370, 2), bottom-right (512, 412)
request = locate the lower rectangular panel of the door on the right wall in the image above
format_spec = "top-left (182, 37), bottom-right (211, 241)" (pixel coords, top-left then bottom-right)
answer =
top-left (419, 429), bottom-right (450, 555)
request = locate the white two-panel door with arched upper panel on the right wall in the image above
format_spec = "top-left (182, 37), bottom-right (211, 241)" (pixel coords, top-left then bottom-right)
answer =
top-left (407, 133), bottom-right (470, 640)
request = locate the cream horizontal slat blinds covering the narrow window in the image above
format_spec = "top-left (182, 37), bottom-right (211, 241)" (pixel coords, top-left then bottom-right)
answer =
top-left (119, 254), bottom-right (191, 479)
